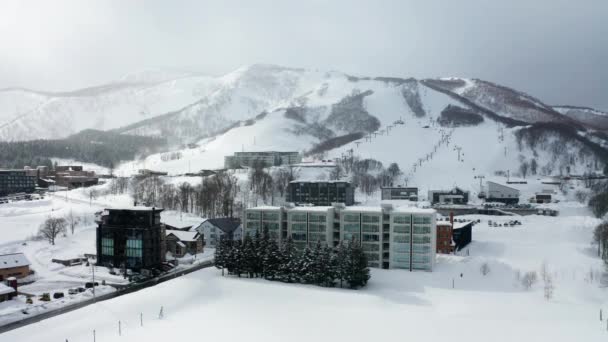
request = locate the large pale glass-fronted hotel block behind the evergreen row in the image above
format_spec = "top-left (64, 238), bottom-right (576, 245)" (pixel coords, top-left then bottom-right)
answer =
top-left (243, 203), bottom-right (437, 271)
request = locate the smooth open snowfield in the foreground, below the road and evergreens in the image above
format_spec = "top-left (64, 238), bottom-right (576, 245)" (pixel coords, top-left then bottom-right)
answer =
top-left (0, 196), bottom-right (608, 342)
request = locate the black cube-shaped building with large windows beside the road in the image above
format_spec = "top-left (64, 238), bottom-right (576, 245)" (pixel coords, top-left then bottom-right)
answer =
top-left (97, 207), bottom-right (165, 271)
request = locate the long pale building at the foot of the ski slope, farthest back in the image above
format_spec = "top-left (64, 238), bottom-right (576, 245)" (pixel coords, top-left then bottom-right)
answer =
top-left (224, 151), bottom-right (302, 169)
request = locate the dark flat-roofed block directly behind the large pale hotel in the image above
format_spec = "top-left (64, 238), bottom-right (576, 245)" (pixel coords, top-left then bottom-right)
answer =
top-left (287, 180), bottom-right (355, 206)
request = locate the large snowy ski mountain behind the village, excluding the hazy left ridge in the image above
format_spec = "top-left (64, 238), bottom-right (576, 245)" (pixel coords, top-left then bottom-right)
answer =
top-left (107, 65), bottom-right (606, 195)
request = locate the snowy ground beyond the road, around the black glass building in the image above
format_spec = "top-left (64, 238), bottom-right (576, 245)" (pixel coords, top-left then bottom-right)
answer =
top-left (0, 185), bottom-right (213, 328)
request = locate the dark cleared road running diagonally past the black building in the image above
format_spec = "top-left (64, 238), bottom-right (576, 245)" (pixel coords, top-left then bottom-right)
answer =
top-left (0, 260), bottom-right (213, 334)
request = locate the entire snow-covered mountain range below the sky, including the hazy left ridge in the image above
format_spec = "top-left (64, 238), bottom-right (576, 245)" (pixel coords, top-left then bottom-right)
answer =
top-left (0, 65), bottom-right (607, 190)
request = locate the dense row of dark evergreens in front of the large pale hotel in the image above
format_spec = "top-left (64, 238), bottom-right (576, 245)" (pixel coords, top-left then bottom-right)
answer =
top-left (215, 229), bottom-right (370, 289)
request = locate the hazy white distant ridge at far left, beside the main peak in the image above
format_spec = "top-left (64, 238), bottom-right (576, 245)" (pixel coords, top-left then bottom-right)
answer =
top-left (0, 72), bottom-right (214, 141)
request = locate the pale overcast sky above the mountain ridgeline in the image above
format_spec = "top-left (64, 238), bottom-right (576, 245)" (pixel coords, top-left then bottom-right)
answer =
top-left (0, 0), bottom-right (608, 110)
